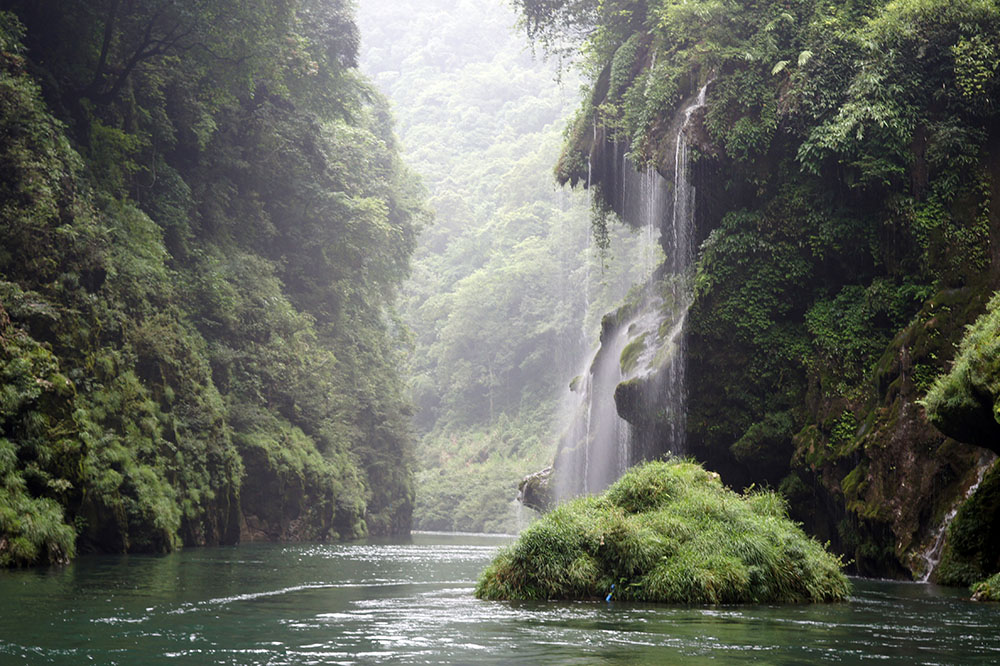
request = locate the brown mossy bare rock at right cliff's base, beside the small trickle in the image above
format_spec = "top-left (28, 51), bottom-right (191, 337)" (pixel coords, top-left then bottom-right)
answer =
top-left (793, 287), bottom-right (983, 577)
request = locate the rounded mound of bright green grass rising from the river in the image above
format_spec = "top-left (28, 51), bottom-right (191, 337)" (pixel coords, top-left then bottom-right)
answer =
top-left (476, 460), bottom-right (850, 604)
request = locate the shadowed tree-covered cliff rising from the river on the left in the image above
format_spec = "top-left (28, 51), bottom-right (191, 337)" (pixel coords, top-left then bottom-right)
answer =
top-left (0, 0), bottom-right (425, 565)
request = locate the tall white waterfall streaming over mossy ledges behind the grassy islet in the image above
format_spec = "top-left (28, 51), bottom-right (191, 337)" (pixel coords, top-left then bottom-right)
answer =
top-left (554, 85), bottom-right (708, 500)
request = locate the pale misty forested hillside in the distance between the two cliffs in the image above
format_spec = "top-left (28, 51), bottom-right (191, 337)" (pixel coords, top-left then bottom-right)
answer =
top-left (359, 0), bottom-right (645, 531)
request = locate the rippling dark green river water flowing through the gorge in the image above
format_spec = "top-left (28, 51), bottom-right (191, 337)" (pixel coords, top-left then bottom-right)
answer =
top-left (0, 534), bottom-right (1000, 666)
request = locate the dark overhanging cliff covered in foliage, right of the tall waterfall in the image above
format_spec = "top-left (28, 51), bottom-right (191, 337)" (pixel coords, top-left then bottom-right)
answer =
top-left (516, 0), bottom-right (1000, 583)
